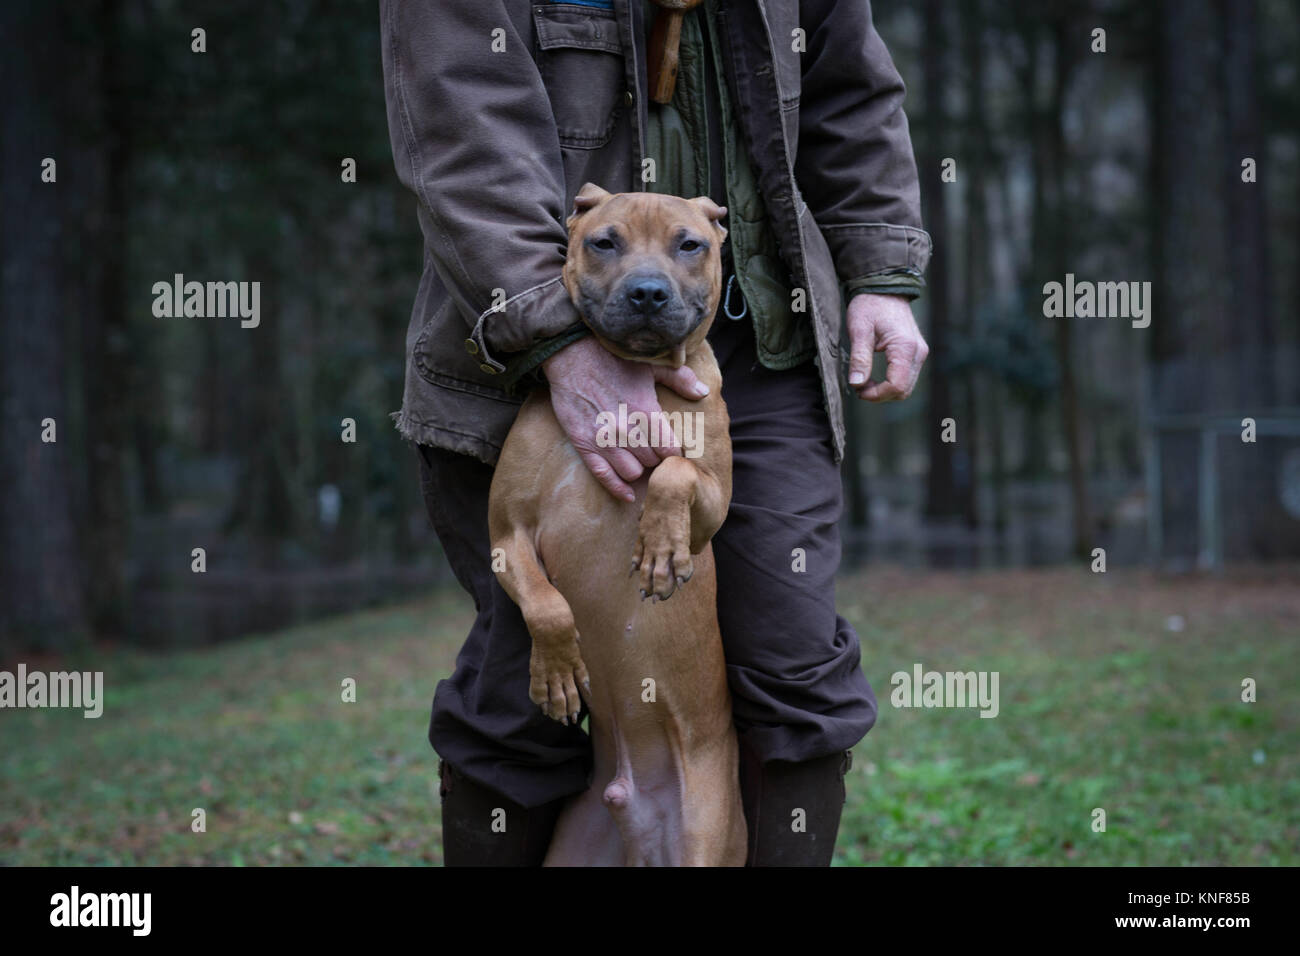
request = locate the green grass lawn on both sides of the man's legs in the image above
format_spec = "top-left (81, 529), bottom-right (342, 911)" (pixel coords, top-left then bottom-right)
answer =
top-left (0, 568), bottom-right (1300, 865)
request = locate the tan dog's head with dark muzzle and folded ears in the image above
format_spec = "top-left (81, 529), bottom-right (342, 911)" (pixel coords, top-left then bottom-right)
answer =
top-left (564, 182), bottom-right (727, 367)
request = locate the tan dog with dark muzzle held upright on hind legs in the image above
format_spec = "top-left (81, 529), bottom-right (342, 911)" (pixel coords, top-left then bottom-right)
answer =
top-left (489, 183), bottom-right (746, 866)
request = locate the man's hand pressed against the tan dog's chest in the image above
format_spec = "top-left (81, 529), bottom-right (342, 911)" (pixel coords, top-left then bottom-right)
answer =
top-left (542, 337), bottom-right (709, 501)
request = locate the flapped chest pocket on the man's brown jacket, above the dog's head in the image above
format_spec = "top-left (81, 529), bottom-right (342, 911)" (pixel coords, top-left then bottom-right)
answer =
top-left (533, 3), bottom-right (625, 150)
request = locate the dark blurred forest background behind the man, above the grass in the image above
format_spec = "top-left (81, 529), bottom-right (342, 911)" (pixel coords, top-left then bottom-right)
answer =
top-left (0, 0), bottom-right (1300, 657)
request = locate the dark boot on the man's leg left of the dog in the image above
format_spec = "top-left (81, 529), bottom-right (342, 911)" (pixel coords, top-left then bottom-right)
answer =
top-left (438, 760), bottom-right (564, 866)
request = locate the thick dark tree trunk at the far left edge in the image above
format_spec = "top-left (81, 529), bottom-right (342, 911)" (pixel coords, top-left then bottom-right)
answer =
top-left (0, 0), bottom-right (86, 649)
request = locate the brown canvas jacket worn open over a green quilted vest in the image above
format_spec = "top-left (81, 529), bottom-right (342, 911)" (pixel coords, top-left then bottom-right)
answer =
top-left (381, 0), bottom-right (931, 463)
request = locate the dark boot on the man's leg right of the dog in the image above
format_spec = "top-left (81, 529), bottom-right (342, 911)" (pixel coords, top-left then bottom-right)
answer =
top-left (740, 741), bottom-right (853, 866)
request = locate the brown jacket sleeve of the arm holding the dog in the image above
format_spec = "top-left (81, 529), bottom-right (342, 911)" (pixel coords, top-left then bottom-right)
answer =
top-left (380, 0), bottom-right (580, 372)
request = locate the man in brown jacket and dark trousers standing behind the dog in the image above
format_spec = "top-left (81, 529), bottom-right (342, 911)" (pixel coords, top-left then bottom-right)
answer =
top-left (381, 0), bottom-right (931, 865)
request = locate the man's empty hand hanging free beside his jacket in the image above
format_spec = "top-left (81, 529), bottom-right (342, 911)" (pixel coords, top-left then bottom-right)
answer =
top-left (848, 293), bottom-right (930, 402)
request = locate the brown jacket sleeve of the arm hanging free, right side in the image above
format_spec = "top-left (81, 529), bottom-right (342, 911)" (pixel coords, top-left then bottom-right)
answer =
top-left (796, 0), bottom-right (931, 282)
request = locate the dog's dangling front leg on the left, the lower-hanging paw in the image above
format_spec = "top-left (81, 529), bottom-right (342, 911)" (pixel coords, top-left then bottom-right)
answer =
top-left (491, 527), bottom-right (588, 723)
